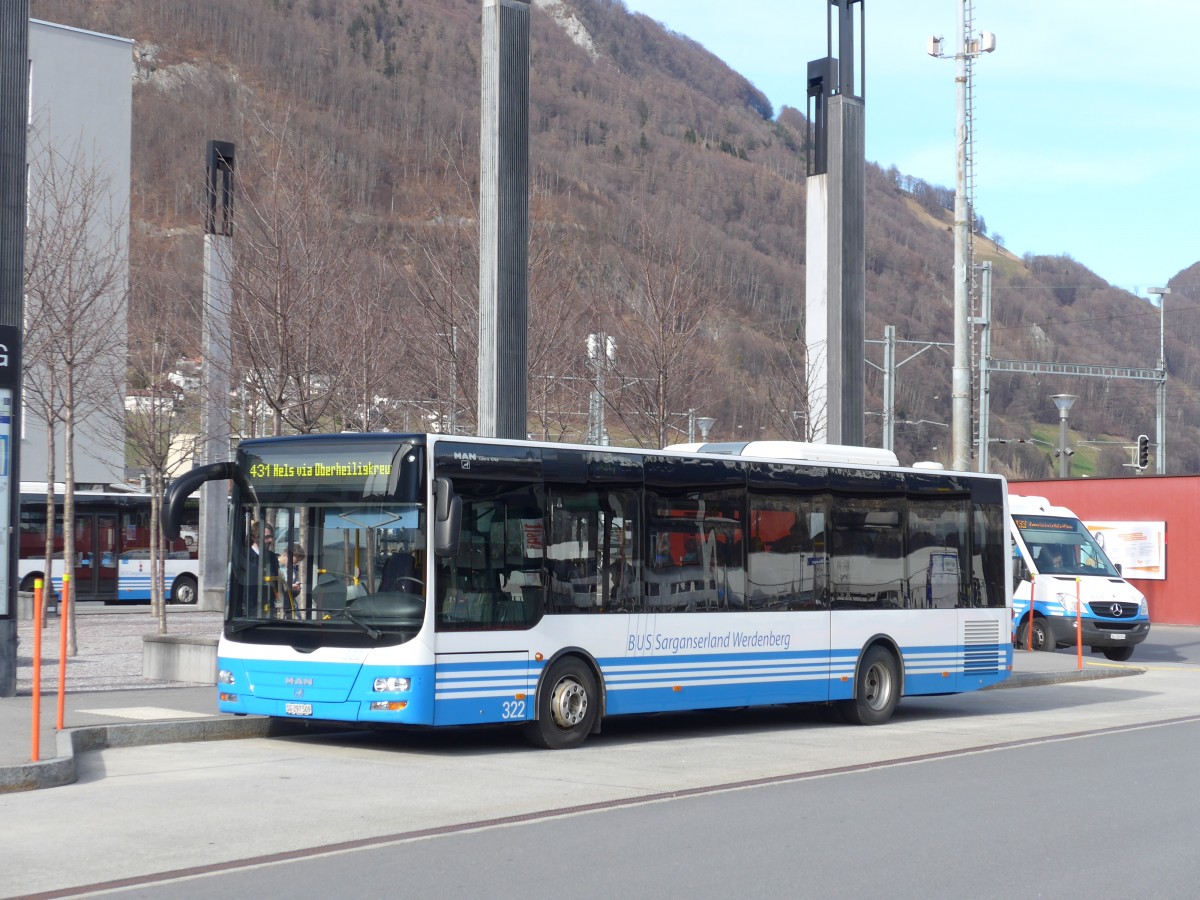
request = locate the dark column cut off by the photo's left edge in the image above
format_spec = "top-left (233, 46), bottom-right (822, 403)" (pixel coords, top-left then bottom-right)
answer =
top-left (0, 0), bottom-right (29, 697)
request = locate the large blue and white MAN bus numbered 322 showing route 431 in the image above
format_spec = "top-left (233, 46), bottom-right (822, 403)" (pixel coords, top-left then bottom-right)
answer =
top-left (164, 433), bottom-right (1013, 748)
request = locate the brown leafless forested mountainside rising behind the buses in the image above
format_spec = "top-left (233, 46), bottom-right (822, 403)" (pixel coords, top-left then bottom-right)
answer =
top-left (23, 0), bottom-right (1200, 478)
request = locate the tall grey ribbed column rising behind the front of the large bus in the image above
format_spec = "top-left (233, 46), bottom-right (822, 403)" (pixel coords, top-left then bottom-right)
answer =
top-left (476, 0), bottom-right (529, 438)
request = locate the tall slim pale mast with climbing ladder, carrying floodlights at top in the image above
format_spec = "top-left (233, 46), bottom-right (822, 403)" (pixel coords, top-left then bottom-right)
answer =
top-left (950, 0), bottom-right (971, 472)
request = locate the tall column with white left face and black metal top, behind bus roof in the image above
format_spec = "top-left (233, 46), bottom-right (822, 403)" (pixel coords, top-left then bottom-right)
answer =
top-left (804, 0), bottom-right (866, 445)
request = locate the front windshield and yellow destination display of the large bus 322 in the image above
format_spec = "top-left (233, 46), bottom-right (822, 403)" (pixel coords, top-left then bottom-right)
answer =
top-left (229, 440), bottom-right (426, 643)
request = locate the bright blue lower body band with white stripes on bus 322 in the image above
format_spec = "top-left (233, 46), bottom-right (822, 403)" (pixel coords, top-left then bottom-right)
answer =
top-left (218, 644), bottom-right (1012, 725)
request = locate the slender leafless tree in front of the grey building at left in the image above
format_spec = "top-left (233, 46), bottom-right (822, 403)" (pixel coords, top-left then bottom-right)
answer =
top-left (24, 130), bottom-right (128, 656)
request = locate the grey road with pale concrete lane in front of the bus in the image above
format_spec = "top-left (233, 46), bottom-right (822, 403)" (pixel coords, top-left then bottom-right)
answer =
top-left (0, 629), bottom-right (1200, 898)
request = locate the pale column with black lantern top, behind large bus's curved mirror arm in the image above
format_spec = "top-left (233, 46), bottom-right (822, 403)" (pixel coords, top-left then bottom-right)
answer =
top-left (199, 140), bottom-right (234, 611)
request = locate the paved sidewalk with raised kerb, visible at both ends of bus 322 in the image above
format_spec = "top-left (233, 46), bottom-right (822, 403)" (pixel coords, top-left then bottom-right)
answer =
top-left (0, 604), bottom-right (1140, 793)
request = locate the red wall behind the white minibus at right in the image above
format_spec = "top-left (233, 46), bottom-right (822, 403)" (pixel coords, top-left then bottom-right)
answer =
top-left (1008, 475), bottom-right (1200, 625)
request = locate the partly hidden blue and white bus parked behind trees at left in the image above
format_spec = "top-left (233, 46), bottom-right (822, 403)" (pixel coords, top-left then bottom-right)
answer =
top-left (17, 482), bottom-right (200, 604)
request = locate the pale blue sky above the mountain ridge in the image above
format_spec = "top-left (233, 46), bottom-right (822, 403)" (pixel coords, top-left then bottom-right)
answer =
top-left (625, 0), bottom-right (1200, 296)
